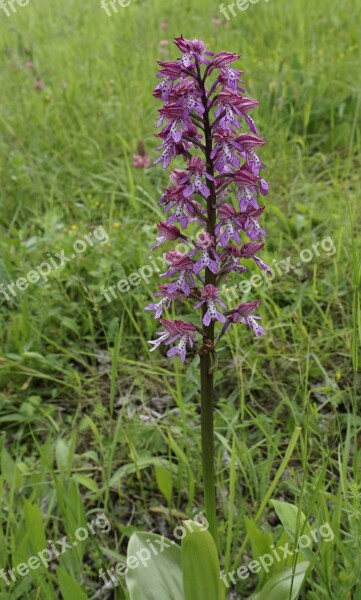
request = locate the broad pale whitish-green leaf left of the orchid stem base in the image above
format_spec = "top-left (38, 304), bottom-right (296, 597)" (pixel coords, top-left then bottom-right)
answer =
top-left (126, 531), bottom-right (184, 600)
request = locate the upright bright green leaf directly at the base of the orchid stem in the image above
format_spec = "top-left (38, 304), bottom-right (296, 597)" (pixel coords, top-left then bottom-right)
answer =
top-left (182, 521), bottom-right (225, 600)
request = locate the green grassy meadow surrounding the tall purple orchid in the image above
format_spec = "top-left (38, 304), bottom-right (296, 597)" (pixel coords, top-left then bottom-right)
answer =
top-left (0, 0), bottom-right (361, 600)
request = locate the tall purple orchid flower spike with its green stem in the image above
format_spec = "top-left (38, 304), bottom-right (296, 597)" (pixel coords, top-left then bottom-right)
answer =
top-left (146, 36), bottom-right (269, 537)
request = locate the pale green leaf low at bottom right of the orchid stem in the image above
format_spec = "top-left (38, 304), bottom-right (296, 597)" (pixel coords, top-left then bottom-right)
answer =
top-left (249, 561), bottom-right (310, 600)
